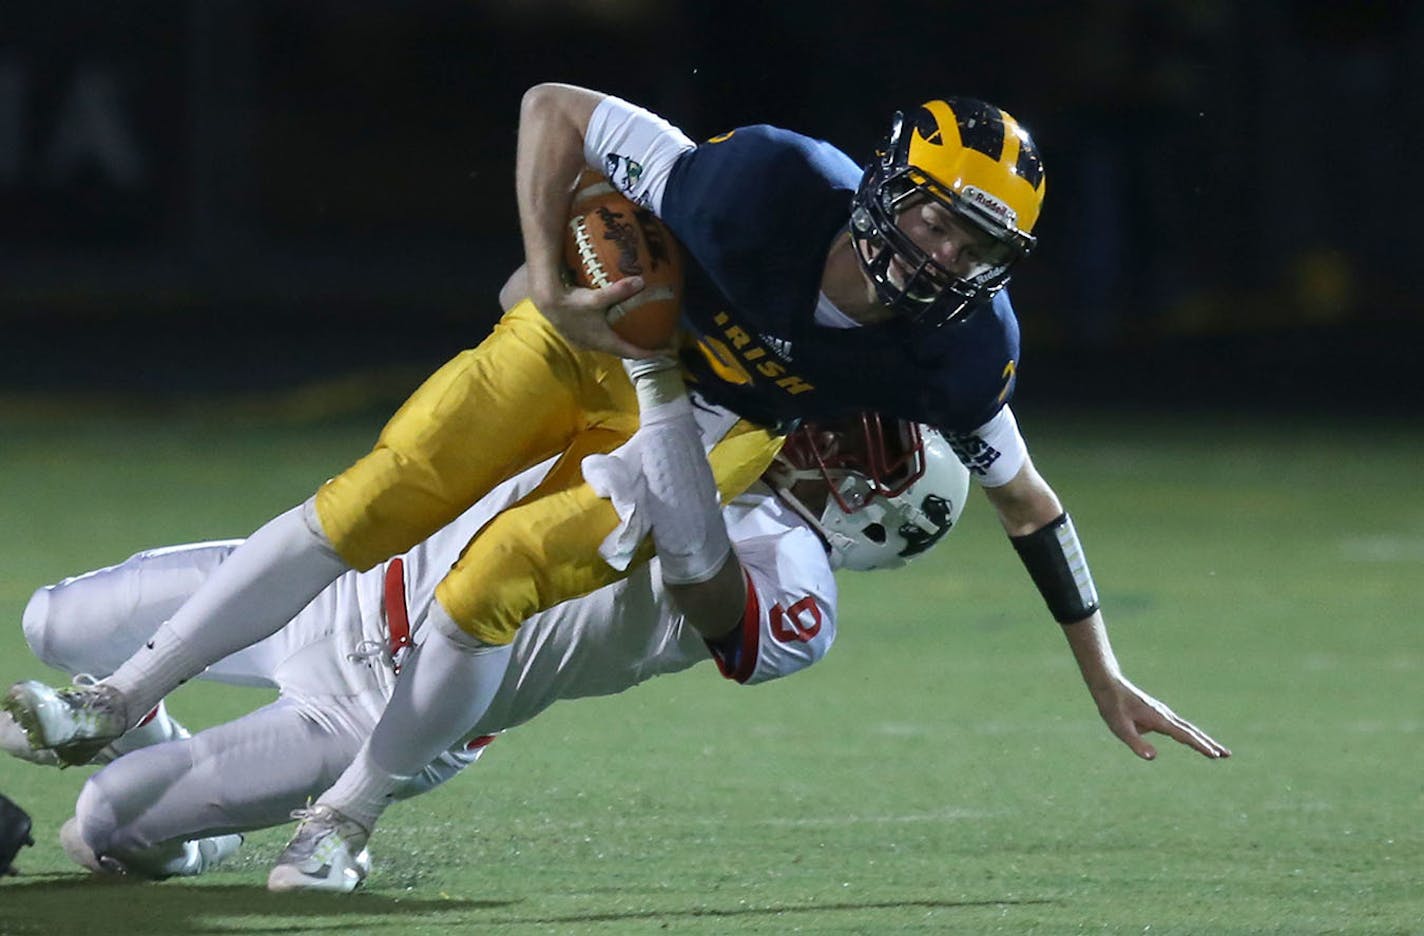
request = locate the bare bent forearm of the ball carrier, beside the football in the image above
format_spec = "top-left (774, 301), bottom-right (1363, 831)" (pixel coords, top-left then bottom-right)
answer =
top-left (514, 84), bottom-right (604, 303)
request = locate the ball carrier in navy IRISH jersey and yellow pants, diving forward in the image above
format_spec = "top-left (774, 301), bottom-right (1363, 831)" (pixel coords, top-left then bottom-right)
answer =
top-left (6, 84), bottom-right (1227, 854)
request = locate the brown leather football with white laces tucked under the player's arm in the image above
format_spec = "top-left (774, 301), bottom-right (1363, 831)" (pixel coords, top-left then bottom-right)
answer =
top-left (564, 171), bottom-right (682, 349)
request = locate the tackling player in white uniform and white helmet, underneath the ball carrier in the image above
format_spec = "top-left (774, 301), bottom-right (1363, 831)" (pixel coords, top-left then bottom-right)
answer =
top-left (0, 398), bottom-right (968, 890)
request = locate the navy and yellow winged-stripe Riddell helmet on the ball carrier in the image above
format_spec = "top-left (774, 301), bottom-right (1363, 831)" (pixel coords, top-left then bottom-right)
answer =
top-left (850, 97), bottom-right (1045, 328)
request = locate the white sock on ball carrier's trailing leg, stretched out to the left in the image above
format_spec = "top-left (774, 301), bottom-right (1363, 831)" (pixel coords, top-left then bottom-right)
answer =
top-left (104, 499), bottom-right (349, 724)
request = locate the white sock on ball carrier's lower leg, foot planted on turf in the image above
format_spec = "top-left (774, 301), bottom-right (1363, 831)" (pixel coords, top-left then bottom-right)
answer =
top-left (318, 601), bottom-right (511, 829)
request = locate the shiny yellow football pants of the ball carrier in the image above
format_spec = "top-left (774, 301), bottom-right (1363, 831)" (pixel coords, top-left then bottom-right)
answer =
top-left (316, 299), bottom-right (782, 644)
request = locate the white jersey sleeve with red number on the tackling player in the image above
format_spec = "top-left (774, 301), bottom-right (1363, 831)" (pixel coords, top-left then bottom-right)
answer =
top-left (708, 530), bottom-right (836, 685)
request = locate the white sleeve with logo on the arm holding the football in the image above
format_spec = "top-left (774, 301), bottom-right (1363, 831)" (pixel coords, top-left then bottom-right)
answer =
top-left (584, 95), bottom-right (696, 217)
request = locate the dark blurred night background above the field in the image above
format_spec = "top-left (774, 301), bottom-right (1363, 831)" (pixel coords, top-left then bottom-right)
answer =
top-left (0, 0), bottom-right (1424, 415)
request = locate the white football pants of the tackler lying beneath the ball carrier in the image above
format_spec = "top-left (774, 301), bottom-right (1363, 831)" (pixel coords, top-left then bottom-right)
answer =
top-left (24, 541), bottom-right (481, 862)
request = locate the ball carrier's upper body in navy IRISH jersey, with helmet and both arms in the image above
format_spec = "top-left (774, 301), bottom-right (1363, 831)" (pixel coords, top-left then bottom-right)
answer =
top-left (515, 84), bottom-right (1226, 759)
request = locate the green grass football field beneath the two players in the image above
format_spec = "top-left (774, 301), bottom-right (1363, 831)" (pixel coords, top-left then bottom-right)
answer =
top-left (0, 407), bottom-right (1424, 935)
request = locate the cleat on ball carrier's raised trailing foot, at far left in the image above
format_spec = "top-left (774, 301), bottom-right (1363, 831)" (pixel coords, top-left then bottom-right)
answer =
top-left (3, 674), bottom-right (128, 765)
